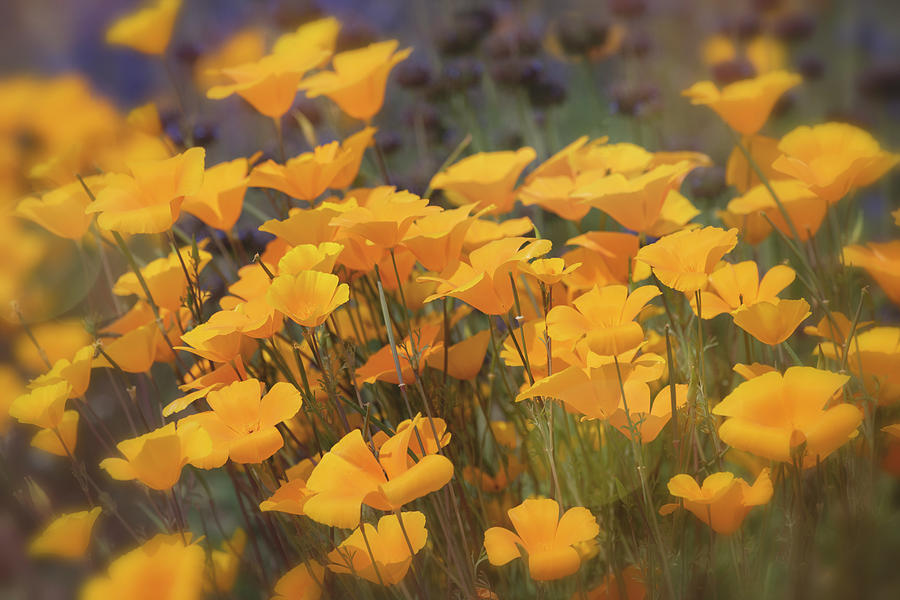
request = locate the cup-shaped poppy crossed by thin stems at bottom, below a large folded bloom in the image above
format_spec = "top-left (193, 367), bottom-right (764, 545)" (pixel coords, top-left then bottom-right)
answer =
top-left (328, 511), bottom-right (428, 585)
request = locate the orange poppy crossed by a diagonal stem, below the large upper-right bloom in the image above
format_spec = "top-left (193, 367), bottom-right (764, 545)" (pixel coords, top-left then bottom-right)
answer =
top-left (727, 179), bottom-right (828, 241)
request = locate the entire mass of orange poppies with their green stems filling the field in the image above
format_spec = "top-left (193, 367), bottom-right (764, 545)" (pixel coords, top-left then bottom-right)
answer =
top-left (0, 0), bottom-right (900, 600)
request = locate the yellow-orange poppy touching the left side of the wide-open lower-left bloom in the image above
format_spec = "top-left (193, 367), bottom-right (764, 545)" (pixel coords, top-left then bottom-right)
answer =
top-left (100, 423), bottom-right (213, 490)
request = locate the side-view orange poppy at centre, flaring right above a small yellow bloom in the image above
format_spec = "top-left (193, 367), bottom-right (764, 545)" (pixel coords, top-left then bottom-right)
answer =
top-left (420, 237), bottom-right (551, 315)
